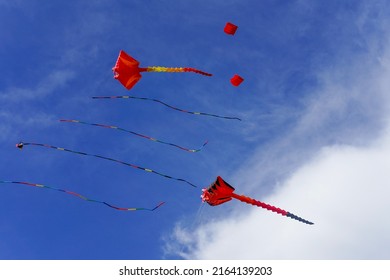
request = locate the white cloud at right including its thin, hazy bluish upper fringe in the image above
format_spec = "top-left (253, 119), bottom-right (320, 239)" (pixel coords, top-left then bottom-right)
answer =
top-left (165, 7), bottom-right (390, 259)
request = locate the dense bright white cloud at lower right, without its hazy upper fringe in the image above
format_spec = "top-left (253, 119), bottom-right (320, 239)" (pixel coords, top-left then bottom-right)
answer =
top-left (166, 121), bottom-right (390, 259)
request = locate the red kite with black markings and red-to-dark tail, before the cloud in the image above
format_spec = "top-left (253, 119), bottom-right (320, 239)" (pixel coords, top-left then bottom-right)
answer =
top-left (201, 176), bottom-right (314, 225)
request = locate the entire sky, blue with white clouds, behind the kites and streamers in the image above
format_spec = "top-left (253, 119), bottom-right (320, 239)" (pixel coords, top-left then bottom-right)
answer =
top-left (0, 0), bottom-right (390, 259)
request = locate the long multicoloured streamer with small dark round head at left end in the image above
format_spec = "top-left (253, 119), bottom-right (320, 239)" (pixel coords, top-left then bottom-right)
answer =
top-left (16, 142), bottom-right (197, 188)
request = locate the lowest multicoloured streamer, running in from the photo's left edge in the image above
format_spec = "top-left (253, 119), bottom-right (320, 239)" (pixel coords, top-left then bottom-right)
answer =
top-left (0, 180), bottom-right (165, 211)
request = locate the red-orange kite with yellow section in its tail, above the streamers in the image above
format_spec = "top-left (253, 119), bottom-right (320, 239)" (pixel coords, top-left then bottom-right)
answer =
top-left (112, 50), bottom-right (212, 90)
